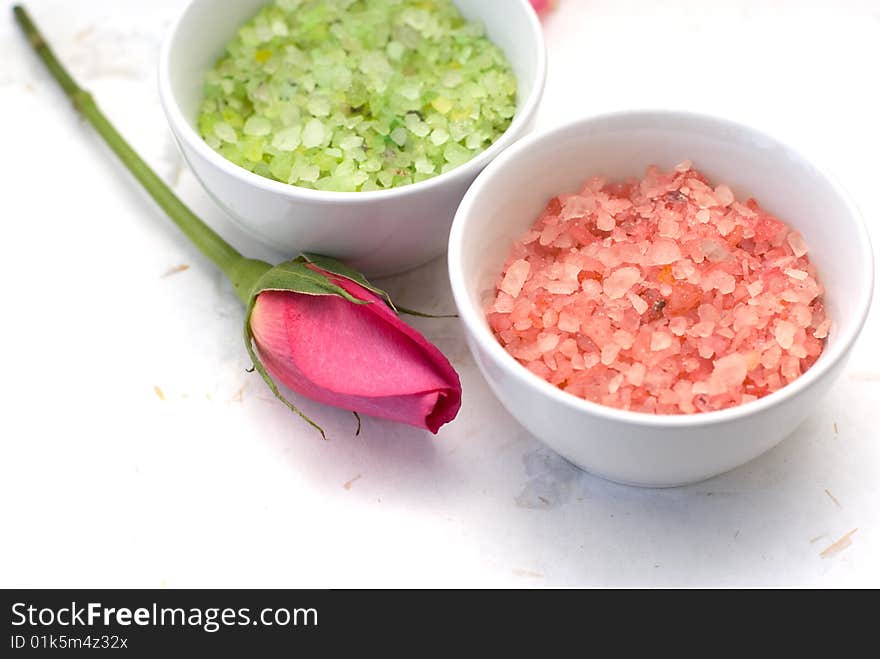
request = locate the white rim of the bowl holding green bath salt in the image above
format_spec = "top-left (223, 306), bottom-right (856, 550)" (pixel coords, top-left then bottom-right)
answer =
top-left (158, 0), bottom-right (547, 203)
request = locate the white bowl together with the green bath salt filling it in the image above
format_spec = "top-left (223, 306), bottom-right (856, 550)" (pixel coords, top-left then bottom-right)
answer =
top-left (159, 0), bottom-right (546, 276)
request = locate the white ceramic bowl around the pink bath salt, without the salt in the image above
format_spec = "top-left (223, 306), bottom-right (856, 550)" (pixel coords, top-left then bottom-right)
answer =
top-left (449, 112), bottom-right (874, 487)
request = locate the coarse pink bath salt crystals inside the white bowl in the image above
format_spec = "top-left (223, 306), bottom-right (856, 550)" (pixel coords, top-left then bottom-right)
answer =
top-left (487, 161), bottom-right (831, 414)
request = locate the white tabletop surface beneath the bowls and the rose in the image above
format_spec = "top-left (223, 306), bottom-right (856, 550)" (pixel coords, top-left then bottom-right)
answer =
top-left (0, 0), bottom-right (880, 587)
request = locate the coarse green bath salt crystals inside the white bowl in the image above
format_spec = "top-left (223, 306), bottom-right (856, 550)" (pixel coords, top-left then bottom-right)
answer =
top-left (198, 0), bottom-right (516, 192)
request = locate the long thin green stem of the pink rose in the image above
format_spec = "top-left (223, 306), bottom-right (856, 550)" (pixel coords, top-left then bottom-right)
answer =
top-left (12, 5), bottom-right (270, 301)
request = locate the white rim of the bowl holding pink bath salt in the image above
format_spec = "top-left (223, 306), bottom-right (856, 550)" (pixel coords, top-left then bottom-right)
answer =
top-left (447, 108), bottom-right (875, 429)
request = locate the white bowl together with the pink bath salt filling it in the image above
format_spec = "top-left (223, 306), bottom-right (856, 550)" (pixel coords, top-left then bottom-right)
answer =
top-left (449, 112), bottom-right (873, 486)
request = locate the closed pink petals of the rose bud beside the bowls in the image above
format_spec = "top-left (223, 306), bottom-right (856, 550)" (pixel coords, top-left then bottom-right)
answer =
top-left (250, 266), bottom-right (461, 433)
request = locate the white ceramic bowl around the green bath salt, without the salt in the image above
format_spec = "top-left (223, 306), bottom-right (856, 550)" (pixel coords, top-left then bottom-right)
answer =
top-left (159, 0), bottom-right (546, 276)
